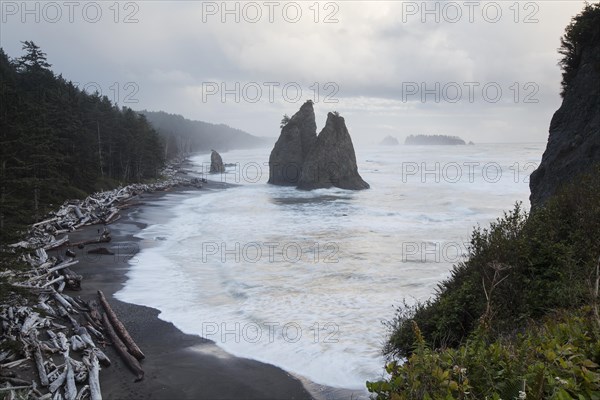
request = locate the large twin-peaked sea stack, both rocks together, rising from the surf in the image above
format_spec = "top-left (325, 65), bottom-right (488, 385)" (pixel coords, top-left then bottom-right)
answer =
top-left (269, 100), bottom-right (369, 190)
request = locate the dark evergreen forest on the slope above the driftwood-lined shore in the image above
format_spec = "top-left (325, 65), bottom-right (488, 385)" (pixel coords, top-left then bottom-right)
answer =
top-left (0, 41), bottom-right (165, 244)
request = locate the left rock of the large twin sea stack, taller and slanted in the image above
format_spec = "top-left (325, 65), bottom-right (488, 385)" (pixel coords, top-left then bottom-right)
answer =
top-left (269, 101), bottom-right (317, 186)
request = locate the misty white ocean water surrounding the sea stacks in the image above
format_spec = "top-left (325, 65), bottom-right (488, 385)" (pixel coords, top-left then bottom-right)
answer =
top-left (115, 143), bottom-right (545, 390)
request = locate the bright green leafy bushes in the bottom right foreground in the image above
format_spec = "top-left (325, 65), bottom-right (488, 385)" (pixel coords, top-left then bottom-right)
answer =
top-left (367, 308), bottom-right (600, 400)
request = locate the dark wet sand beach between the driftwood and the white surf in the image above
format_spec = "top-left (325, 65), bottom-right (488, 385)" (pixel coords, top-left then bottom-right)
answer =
top-left (50, 183), bottom-right (318, 399)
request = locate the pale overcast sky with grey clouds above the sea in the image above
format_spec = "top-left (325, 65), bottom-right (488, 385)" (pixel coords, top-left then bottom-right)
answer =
top-left (0, 0), bottom-right (584, 144)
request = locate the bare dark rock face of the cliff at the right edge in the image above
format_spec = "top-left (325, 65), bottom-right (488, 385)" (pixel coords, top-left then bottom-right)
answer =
top-left (529, 39), bottom-right (600, 208)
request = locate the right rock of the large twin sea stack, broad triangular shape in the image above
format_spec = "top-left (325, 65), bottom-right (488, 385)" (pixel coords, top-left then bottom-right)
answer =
top-left (298, 113), bottom-right (369, 190)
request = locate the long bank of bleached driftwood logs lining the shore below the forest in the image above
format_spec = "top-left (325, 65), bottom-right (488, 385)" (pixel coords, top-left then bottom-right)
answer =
top-left (0, 168), bottom-right (201, 400)
